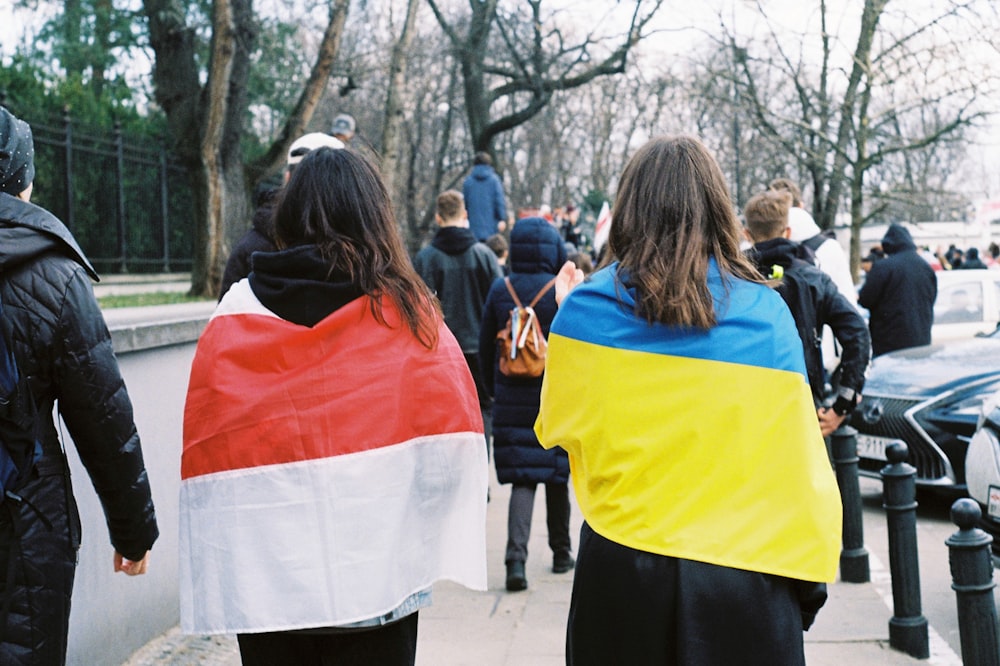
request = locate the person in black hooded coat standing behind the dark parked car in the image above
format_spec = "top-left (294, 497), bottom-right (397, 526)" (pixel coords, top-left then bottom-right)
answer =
top-left (858, 224), bottom-right (937, 356)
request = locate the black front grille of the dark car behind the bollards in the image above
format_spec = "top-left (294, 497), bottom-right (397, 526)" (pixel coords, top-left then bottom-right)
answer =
top-left (851, 396), bottom-right (947, 480)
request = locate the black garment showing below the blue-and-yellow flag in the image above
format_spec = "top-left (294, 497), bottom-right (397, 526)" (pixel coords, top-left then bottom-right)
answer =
top-left (566, 523), bottom-right (805, 666)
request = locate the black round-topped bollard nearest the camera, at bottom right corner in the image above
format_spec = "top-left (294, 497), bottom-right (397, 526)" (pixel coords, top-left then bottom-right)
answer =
top-left (945, 498), bottom-right (1000, 666)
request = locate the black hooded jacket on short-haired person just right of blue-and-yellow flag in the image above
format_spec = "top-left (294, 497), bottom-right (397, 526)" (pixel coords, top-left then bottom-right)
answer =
top-left (749, 238), bottom-right (871, 405)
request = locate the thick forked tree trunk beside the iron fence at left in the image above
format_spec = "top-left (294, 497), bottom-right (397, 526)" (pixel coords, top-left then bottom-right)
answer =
top-left (144, 0), bottom-right (349, 297)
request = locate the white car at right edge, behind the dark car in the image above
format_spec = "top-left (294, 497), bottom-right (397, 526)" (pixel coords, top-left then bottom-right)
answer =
top-left (931, 269), bottom-right (1000, 343)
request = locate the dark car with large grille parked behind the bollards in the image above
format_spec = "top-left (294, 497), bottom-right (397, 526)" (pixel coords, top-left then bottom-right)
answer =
top-left (850, 324), bottom-right (1000, 494)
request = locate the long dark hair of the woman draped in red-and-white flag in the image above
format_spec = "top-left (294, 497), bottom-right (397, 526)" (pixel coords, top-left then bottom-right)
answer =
top-left (274, 148), bottom-right (440, 348)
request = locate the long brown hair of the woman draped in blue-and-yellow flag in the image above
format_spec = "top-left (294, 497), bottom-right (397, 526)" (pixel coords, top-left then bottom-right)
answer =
top-left (607, 136), bottom-right (761, 330)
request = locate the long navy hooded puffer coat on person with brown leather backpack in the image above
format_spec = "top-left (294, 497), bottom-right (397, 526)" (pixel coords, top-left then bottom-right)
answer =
top-left (479, 217), bottom-right (569, 483)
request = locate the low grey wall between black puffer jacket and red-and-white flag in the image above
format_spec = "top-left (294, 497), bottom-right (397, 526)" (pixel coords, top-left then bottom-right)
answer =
top-left (60, 303), bottom-right (214, 666)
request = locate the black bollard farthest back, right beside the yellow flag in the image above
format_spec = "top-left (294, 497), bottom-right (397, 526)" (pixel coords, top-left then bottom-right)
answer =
top-left (830, 425), bottom-right (871, 583)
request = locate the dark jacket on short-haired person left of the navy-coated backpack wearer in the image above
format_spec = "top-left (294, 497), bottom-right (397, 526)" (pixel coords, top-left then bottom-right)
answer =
top-left (413, 227), bottom-right (503, 354)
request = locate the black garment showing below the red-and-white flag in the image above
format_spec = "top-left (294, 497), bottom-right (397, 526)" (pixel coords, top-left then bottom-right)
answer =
top-left (236, 613), bottom-right (417, 666)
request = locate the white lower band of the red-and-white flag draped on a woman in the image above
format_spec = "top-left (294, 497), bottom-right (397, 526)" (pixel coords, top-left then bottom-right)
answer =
top-left (180, 433), bottom-right (488, 634)
